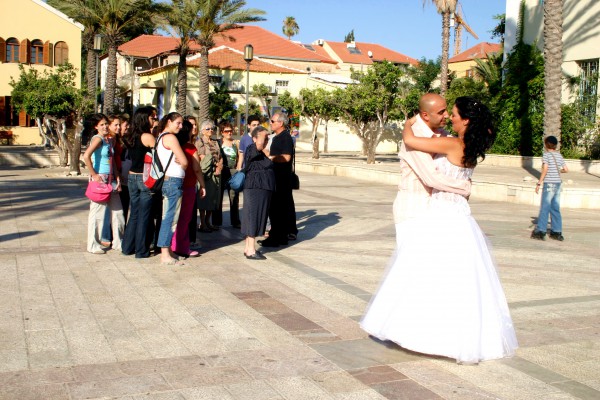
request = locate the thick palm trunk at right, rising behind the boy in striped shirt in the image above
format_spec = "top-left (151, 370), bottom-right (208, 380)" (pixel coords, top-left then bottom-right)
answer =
top-left (544, 0), bottom-right (563, 143)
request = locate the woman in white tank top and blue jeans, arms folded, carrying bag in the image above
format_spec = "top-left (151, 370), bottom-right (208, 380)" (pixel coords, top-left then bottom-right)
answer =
top-left (156, 112), bottom-right (187, 265)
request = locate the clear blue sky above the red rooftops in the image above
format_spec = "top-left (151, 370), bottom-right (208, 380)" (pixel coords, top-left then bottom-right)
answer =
top-left (241, 0), bottom-right (506, 59)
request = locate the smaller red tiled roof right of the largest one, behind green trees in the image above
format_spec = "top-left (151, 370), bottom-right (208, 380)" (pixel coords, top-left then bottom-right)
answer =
top-left (315, 41), bottom-right (419, 65)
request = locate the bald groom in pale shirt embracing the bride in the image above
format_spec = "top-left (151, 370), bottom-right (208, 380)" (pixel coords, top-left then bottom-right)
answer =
top-left (394, 93), bottom-right (471, 230)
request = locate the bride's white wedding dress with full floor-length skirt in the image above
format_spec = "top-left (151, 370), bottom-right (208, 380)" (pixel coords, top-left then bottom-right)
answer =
top-left (361, 157), bottom-right (518, 363)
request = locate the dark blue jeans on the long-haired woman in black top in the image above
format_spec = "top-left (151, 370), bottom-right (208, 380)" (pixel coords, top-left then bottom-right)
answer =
top-left (123, 174), bottom-right (152, 258)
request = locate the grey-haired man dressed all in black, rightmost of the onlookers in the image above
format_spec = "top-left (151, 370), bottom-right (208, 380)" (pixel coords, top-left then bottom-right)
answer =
top-left (258, 112), bottom-right (297, 247)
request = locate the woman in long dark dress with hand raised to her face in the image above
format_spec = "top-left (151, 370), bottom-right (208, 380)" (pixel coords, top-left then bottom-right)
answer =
top-left (242, 126), bottom-right (275, 260)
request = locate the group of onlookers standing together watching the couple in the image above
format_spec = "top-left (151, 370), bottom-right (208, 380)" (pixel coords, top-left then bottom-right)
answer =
top-left (83, 107), bottom-right (298, 265)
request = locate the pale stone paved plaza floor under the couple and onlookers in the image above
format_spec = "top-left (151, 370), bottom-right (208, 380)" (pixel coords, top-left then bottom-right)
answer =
top-left (0, 167), bottom-right (600, 400)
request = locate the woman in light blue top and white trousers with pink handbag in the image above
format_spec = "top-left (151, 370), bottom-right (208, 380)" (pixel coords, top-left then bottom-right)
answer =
top-left (83, 114), bottom-right (125, 254)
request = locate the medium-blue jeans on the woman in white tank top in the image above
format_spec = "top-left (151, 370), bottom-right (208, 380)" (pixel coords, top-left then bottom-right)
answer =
top-left (156, 176), bottom-right (183, 248)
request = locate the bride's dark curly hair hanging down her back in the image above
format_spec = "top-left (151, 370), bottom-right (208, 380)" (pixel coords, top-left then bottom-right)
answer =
top-left (454, 96), bottom-right (496, 168)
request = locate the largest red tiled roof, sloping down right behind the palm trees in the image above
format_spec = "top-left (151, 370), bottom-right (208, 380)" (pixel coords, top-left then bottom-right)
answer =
top-left (215, 25), bottom-right (337, 64)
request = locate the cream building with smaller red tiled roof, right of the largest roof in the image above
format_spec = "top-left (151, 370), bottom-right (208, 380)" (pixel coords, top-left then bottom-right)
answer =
top-left (312, 39), bottom-right (419, 75)
